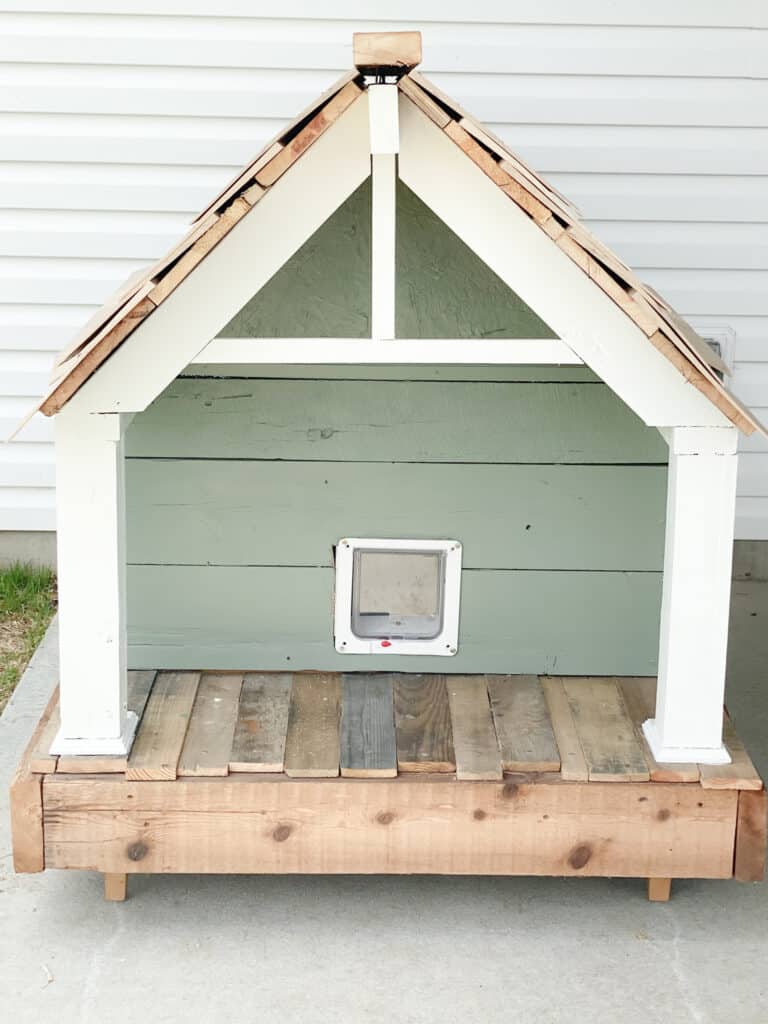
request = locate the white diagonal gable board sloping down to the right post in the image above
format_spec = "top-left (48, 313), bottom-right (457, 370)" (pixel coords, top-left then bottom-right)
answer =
top-left (398, 95), bottom-right (729, 427)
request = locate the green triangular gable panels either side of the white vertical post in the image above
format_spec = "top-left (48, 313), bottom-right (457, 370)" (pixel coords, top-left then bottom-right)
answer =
top-left (219, 179), bottom-right (554, 338)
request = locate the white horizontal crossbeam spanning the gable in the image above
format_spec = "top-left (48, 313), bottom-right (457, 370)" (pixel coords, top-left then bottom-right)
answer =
top-left (189, 338), bottom-right (583, 366)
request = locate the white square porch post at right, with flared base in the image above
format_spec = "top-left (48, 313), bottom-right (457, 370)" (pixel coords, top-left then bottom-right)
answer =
top-left (643, 427), bottom-right (738, 764)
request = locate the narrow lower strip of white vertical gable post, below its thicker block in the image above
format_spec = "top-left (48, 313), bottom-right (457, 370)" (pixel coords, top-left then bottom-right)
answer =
top-left (371, 152), bottom-right (397, 339)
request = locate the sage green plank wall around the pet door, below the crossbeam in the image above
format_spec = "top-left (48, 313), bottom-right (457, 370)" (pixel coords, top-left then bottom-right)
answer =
top-left (127, 367), bottom-right (666, 675)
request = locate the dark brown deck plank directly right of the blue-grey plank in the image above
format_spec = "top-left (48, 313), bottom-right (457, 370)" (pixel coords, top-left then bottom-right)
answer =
top-left (394, 674), bottom-right (456, 772)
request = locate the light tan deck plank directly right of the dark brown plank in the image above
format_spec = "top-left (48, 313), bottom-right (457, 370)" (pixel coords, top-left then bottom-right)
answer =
top-left (445, 676), bottom-right (504, 780)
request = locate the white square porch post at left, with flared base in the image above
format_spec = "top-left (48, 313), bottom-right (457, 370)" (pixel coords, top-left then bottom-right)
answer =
top-left (51, 399), bottom-right (136, 754)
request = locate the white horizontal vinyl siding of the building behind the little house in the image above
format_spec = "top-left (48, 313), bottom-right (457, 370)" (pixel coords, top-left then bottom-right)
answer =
top-left (0, 0), bottom-right (768, 539)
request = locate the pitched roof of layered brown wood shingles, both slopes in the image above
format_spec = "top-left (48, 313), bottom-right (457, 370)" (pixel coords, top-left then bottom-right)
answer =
top-left (28, 33), bottom-right (768, 434)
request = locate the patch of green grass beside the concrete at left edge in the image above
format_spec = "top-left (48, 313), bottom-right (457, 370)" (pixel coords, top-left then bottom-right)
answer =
top-left (0, 565), bottom-right (56, 712)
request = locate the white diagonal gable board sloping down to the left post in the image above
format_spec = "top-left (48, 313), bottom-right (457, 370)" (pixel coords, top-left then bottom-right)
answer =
top-left (70, 93), bottom-right (371, 413)
